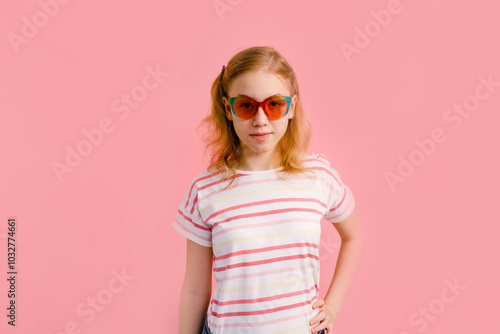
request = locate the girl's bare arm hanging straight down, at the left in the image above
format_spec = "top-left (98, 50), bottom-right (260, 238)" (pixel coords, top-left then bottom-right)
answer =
top-left (179, 239), bottom-right (213, 334)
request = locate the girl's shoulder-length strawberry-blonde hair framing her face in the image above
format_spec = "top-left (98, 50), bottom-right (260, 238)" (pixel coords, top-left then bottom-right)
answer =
top-left (200, 46), bottom-right (314, 189)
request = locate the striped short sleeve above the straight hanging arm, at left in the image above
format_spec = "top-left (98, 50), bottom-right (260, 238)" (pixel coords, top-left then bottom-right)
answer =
top-left (172, 178), bottom-right (212, 247)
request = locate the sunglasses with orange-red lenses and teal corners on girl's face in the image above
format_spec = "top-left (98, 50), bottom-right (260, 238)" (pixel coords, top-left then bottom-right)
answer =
top-left (229, 95), bottom-right (292, 120)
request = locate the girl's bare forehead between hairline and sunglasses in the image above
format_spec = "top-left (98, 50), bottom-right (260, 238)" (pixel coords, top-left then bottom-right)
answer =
top-left (228, 70), bottom-right (290, 101)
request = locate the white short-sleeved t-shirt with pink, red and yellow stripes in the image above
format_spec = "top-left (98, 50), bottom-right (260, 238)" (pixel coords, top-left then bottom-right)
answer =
top-left (172, 153), bottom-right (354, 334)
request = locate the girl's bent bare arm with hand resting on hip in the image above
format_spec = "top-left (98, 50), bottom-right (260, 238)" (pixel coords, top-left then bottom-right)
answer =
top-left (310, 211), bottom-right (365, 333)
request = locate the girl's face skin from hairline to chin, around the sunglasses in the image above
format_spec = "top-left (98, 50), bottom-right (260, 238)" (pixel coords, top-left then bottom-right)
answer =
top-left (222, 70), bottom-right (297, 170)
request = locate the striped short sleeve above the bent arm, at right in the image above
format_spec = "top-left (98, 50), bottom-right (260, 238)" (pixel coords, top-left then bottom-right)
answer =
top-left (324, 166), bottom-right (355, 223)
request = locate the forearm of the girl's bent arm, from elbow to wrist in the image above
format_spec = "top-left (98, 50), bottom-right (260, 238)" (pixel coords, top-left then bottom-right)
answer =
top-left (324, 237), bottom-right (364, 317)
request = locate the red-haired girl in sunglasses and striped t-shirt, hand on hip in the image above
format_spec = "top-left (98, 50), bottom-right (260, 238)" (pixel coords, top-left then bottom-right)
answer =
top-left (172, 47), bottom-right (363, 334)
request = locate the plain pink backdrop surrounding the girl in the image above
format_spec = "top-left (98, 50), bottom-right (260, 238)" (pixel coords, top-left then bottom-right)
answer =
top-left (0, 0), bottom-right (500, 334)
